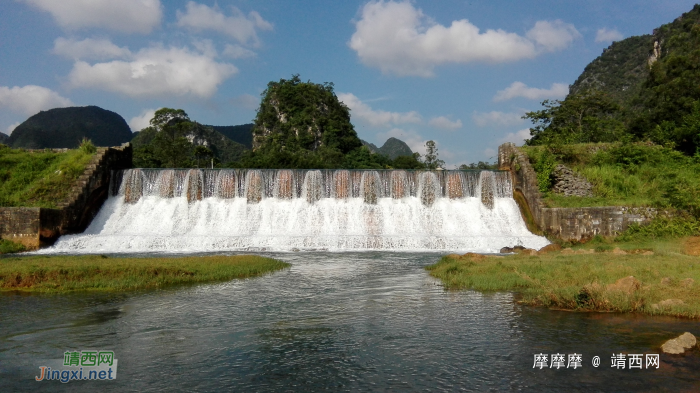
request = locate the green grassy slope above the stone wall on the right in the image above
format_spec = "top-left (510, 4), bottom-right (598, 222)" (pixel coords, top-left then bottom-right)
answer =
top-left (522, 143), bottom-right (700, 210)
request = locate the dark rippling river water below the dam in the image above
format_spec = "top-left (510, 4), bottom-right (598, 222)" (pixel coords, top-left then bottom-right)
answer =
top-left (0, 252), bottom-right (700, 392)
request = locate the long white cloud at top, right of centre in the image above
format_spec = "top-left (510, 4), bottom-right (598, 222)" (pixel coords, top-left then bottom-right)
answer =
top-left (348, 1), bottom-right (580, 77)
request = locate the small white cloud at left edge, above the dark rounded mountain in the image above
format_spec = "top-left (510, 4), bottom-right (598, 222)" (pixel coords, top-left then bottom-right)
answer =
top-left (0, 85), bottom-right (73, 116)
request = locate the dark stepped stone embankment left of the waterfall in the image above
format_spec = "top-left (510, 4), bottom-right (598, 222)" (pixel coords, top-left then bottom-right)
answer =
top-left (0, 143), bottom-right (132, 250)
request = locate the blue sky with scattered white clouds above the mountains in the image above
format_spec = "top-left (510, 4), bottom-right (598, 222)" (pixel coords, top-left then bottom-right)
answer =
top-left (0, 0), bottom-right (694, 168)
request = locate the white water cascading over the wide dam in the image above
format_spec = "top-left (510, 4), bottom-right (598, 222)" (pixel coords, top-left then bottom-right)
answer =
top-left (40, 169), bottom-right (548, 253)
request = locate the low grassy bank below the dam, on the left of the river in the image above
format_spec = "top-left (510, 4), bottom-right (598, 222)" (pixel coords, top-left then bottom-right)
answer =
top-left (0, 255), bottom-right (289, 292)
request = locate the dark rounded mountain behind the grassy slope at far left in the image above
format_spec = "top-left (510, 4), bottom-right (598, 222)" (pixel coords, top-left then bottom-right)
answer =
top-left (7, 106), bottom-right (132, 149)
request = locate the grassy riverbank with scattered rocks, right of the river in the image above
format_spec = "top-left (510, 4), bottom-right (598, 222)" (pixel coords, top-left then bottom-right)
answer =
top-left (426, 238), bottom-right (700, 318)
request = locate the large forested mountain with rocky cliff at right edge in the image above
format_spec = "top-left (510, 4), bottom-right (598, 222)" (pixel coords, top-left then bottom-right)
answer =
top-left (526, 5), bottom-right (700, 155)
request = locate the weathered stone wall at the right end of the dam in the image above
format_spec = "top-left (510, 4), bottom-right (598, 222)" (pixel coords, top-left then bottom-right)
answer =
top-left (498, 143), bottom-right (659, 241)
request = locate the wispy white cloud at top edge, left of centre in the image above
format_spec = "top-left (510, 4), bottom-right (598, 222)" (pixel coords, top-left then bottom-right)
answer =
top-left (177, 1), bottom-right (273, 46)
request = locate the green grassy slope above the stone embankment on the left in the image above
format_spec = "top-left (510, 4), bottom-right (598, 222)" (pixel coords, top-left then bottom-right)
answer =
top-left (0, 145), bottom-right (94, 208)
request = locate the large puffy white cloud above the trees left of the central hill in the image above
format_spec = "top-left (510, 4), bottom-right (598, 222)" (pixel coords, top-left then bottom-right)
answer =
top-left (68, 46), bottom-right (238, 98)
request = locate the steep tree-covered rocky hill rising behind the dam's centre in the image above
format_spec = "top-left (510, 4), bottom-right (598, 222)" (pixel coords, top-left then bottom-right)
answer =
top-left (235, 75), bottom-right (423, 169)
